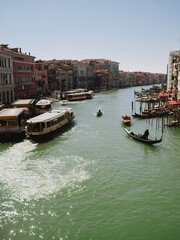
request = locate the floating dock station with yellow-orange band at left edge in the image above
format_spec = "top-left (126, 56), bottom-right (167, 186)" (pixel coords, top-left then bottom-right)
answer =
top-left (0, 108), bottom-right (26, 141)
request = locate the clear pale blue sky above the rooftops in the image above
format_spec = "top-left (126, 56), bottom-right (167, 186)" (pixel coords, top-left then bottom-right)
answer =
top-left (0, 0), bottom-right (180, 73)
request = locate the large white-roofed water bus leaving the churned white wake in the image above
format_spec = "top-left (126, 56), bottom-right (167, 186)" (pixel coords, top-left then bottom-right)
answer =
top-left (26, 108), bottom-right (75, 139)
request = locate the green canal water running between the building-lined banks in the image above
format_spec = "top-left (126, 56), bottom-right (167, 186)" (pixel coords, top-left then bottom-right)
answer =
top-left (0, 86), bottom-right (180, 240)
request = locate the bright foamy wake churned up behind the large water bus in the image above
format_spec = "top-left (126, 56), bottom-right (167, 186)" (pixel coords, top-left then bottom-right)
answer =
top-left (0, 140), bottom-right (89, 200)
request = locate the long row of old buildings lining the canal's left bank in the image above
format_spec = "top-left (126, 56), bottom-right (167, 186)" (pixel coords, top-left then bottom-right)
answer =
top-left (0, 44), bottom-right (167, 104)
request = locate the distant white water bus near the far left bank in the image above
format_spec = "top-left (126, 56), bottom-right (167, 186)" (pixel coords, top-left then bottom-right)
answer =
top-left (62, 89), bottom-right (94, 101)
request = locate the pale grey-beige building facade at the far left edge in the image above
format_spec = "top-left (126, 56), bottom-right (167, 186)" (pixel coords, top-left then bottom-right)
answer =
top-left (0, 44), bottom-right (14, 104)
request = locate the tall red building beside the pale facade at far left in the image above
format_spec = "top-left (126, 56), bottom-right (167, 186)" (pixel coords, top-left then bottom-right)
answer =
top-left (10, 48), bottom-right (36, 99)
